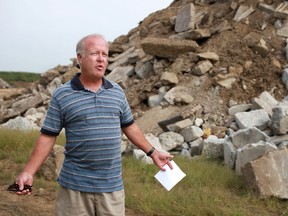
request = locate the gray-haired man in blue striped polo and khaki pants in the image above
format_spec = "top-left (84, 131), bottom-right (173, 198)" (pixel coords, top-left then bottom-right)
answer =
top-left (16, 34), bottom-right (172, 216)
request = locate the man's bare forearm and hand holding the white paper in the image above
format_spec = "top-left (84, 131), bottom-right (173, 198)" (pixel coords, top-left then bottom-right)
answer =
top-left (122, 123), bottom-right (173, 171)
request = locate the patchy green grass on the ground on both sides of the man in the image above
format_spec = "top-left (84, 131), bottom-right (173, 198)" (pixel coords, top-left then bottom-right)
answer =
top-left (0, 129), bottom-right (288, 216)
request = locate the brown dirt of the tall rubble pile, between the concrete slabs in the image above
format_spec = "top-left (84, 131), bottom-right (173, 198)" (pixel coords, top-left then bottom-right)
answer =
top-left (111, 0), bottom-right (287, 125)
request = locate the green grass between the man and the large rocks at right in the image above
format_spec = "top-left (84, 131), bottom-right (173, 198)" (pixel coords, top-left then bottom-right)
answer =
top-left (123, 157), bottom-right (288, 216)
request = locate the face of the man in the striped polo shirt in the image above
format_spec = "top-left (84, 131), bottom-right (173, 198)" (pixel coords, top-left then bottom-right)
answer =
top-left (77, 37), bottom-right (108, 79)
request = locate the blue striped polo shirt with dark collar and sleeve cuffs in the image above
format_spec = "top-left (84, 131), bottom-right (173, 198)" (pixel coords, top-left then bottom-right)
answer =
top-left (41, 73), bottom-right (134, 193)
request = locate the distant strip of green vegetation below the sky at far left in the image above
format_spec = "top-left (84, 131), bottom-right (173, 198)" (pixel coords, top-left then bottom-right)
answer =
top-left (0, 71), bottom-right (41, 85)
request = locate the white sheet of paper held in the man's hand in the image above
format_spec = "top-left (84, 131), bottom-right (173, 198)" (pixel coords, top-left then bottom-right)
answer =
top-left (154, 161), bottom-right (186, 191)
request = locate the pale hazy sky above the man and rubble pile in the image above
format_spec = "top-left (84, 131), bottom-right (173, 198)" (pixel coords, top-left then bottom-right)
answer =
top-left (0, 0), bottom-right (173, 73)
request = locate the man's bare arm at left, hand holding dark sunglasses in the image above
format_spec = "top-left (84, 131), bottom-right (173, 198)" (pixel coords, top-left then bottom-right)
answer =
top-left (16, 134), bottom-right (56, 195)
